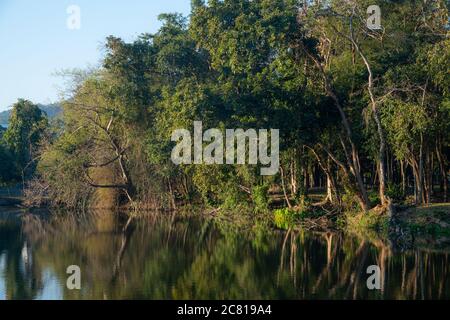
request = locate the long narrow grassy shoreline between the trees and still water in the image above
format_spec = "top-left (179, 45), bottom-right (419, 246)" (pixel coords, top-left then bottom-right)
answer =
top-left (0, 191), bottom-right (450, 254)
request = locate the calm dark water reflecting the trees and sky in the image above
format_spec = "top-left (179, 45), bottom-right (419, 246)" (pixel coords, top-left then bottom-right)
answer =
top-left (0, 209), bottom-right (450, 299)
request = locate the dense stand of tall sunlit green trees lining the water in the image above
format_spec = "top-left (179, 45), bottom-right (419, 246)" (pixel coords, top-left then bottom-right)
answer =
top-left (20, 0), bottom-right (450, 210)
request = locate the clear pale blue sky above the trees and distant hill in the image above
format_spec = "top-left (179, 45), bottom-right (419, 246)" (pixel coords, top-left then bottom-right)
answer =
top-left (0, 0), bottom-right (191, 111)
